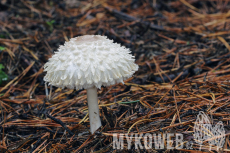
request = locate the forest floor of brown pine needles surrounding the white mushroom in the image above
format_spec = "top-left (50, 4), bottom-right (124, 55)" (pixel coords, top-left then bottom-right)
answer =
top-left (0, 0), bottom-right (230, 153)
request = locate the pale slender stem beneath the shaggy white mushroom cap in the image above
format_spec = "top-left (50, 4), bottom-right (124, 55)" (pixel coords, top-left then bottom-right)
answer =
top-left (87, 87), bottom-right (101, 134)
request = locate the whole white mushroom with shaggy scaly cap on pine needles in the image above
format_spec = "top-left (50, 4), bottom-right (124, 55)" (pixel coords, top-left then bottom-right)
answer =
top-left (44, 35), bottom-right (138, 134)
